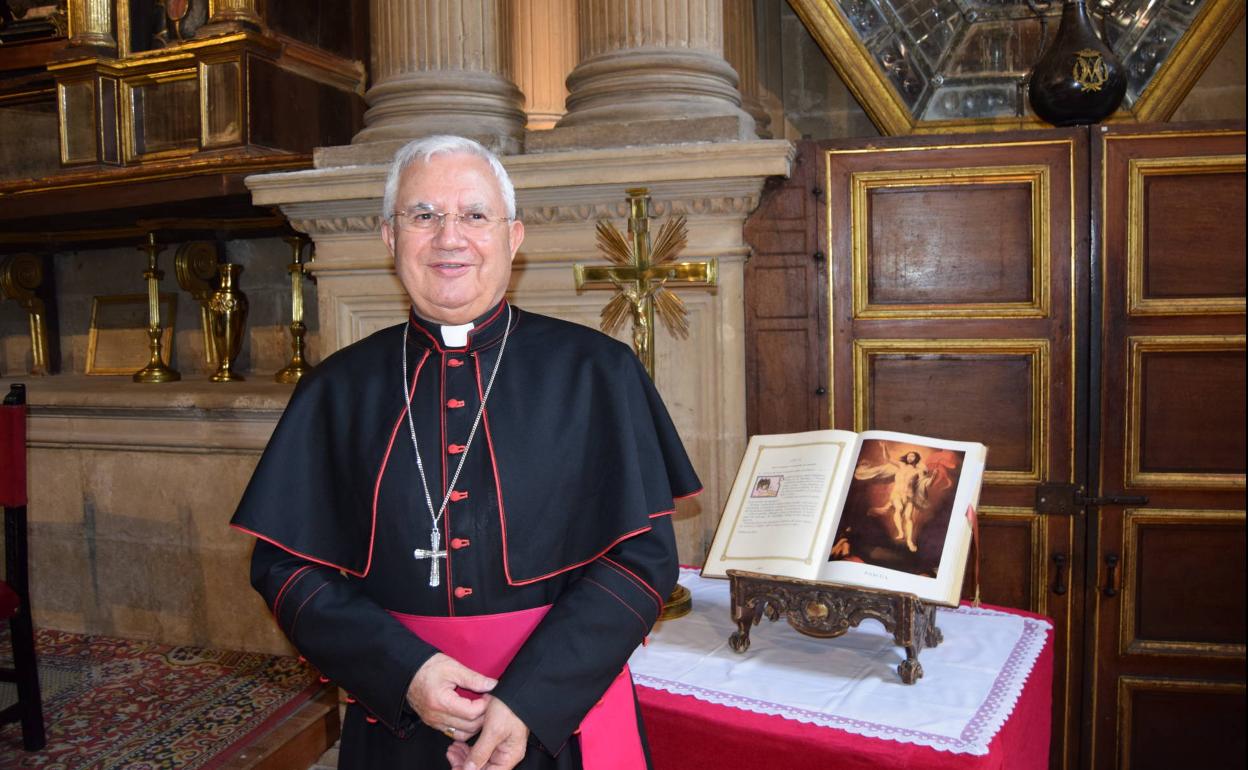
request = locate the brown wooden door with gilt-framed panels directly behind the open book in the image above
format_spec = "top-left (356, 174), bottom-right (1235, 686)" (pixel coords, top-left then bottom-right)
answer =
top-left (819, 130), bottom-right (1087, 768)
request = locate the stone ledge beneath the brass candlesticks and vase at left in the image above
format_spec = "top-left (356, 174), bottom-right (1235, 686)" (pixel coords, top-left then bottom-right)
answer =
top-left (2, 376), bottom-right (293, 453)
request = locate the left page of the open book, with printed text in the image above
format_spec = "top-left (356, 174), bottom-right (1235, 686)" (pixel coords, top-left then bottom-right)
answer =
top-left (703, 431), bottom-right (857, 578)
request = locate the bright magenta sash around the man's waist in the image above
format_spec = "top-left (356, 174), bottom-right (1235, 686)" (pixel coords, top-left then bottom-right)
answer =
top-left (391, 605), bottom-right (645, 770)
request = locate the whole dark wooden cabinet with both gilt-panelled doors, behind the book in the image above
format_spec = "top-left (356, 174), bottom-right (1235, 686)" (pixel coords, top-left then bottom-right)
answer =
top-left (746, 122), bottom-right (1244, 768)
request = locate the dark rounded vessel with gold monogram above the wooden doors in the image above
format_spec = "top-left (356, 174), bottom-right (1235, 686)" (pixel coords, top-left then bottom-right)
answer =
top-left (1028, 0), bottom-right (1127, 126)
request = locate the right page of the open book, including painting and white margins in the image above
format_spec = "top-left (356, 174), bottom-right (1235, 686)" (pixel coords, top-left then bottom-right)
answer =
top-left (820, 431), bottom-right (987, 604)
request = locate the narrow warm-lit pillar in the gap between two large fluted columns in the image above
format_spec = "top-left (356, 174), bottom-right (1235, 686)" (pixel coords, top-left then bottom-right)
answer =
top-left (512, 0), bottom-right (577, 131)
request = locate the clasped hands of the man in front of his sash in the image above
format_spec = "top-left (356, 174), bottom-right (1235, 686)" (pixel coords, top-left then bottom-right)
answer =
top-left (407, 653), bottom-right (529, 770)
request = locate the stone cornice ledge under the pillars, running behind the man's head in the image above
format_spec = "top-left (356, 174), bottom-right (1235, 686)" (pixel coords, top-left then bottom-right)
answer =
top-left (246, 140), bottom-right (796, 206)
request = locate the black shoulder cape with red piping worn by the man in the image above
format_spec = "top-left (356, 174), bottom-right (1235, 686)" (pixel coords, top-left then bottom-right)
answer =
top-left (231, 305), bottom-right (701, 584)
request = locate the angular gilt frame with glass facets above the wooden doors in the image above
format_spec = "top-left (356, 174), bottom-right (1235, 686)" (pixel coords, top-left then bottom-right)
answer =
top-left (790, 0), bottom-right (1244, 136)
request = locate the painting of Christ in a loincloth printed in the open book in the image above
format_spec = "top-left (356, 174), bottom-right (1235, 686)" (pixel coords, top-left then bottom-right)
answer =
top-left (829, 439), bottom-right (965, 578)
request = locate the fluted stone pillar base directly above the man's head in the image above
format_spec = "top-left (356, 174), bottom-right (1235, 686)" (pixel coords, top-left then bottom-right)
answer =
top-left (352, 0), bottom-right (524, 152)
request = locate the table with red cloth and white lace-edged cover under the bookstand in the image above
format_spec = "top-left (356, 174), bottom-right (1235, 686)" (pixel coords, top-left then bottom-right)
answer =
top-left (630, 569), bottom-right (1053, 770)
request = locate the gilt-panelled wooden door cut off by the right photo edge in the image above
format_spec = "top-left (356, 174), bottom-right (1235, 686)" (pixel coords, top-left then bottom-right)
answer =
top-left (1083, 126), bottom-right (1246, 770)
